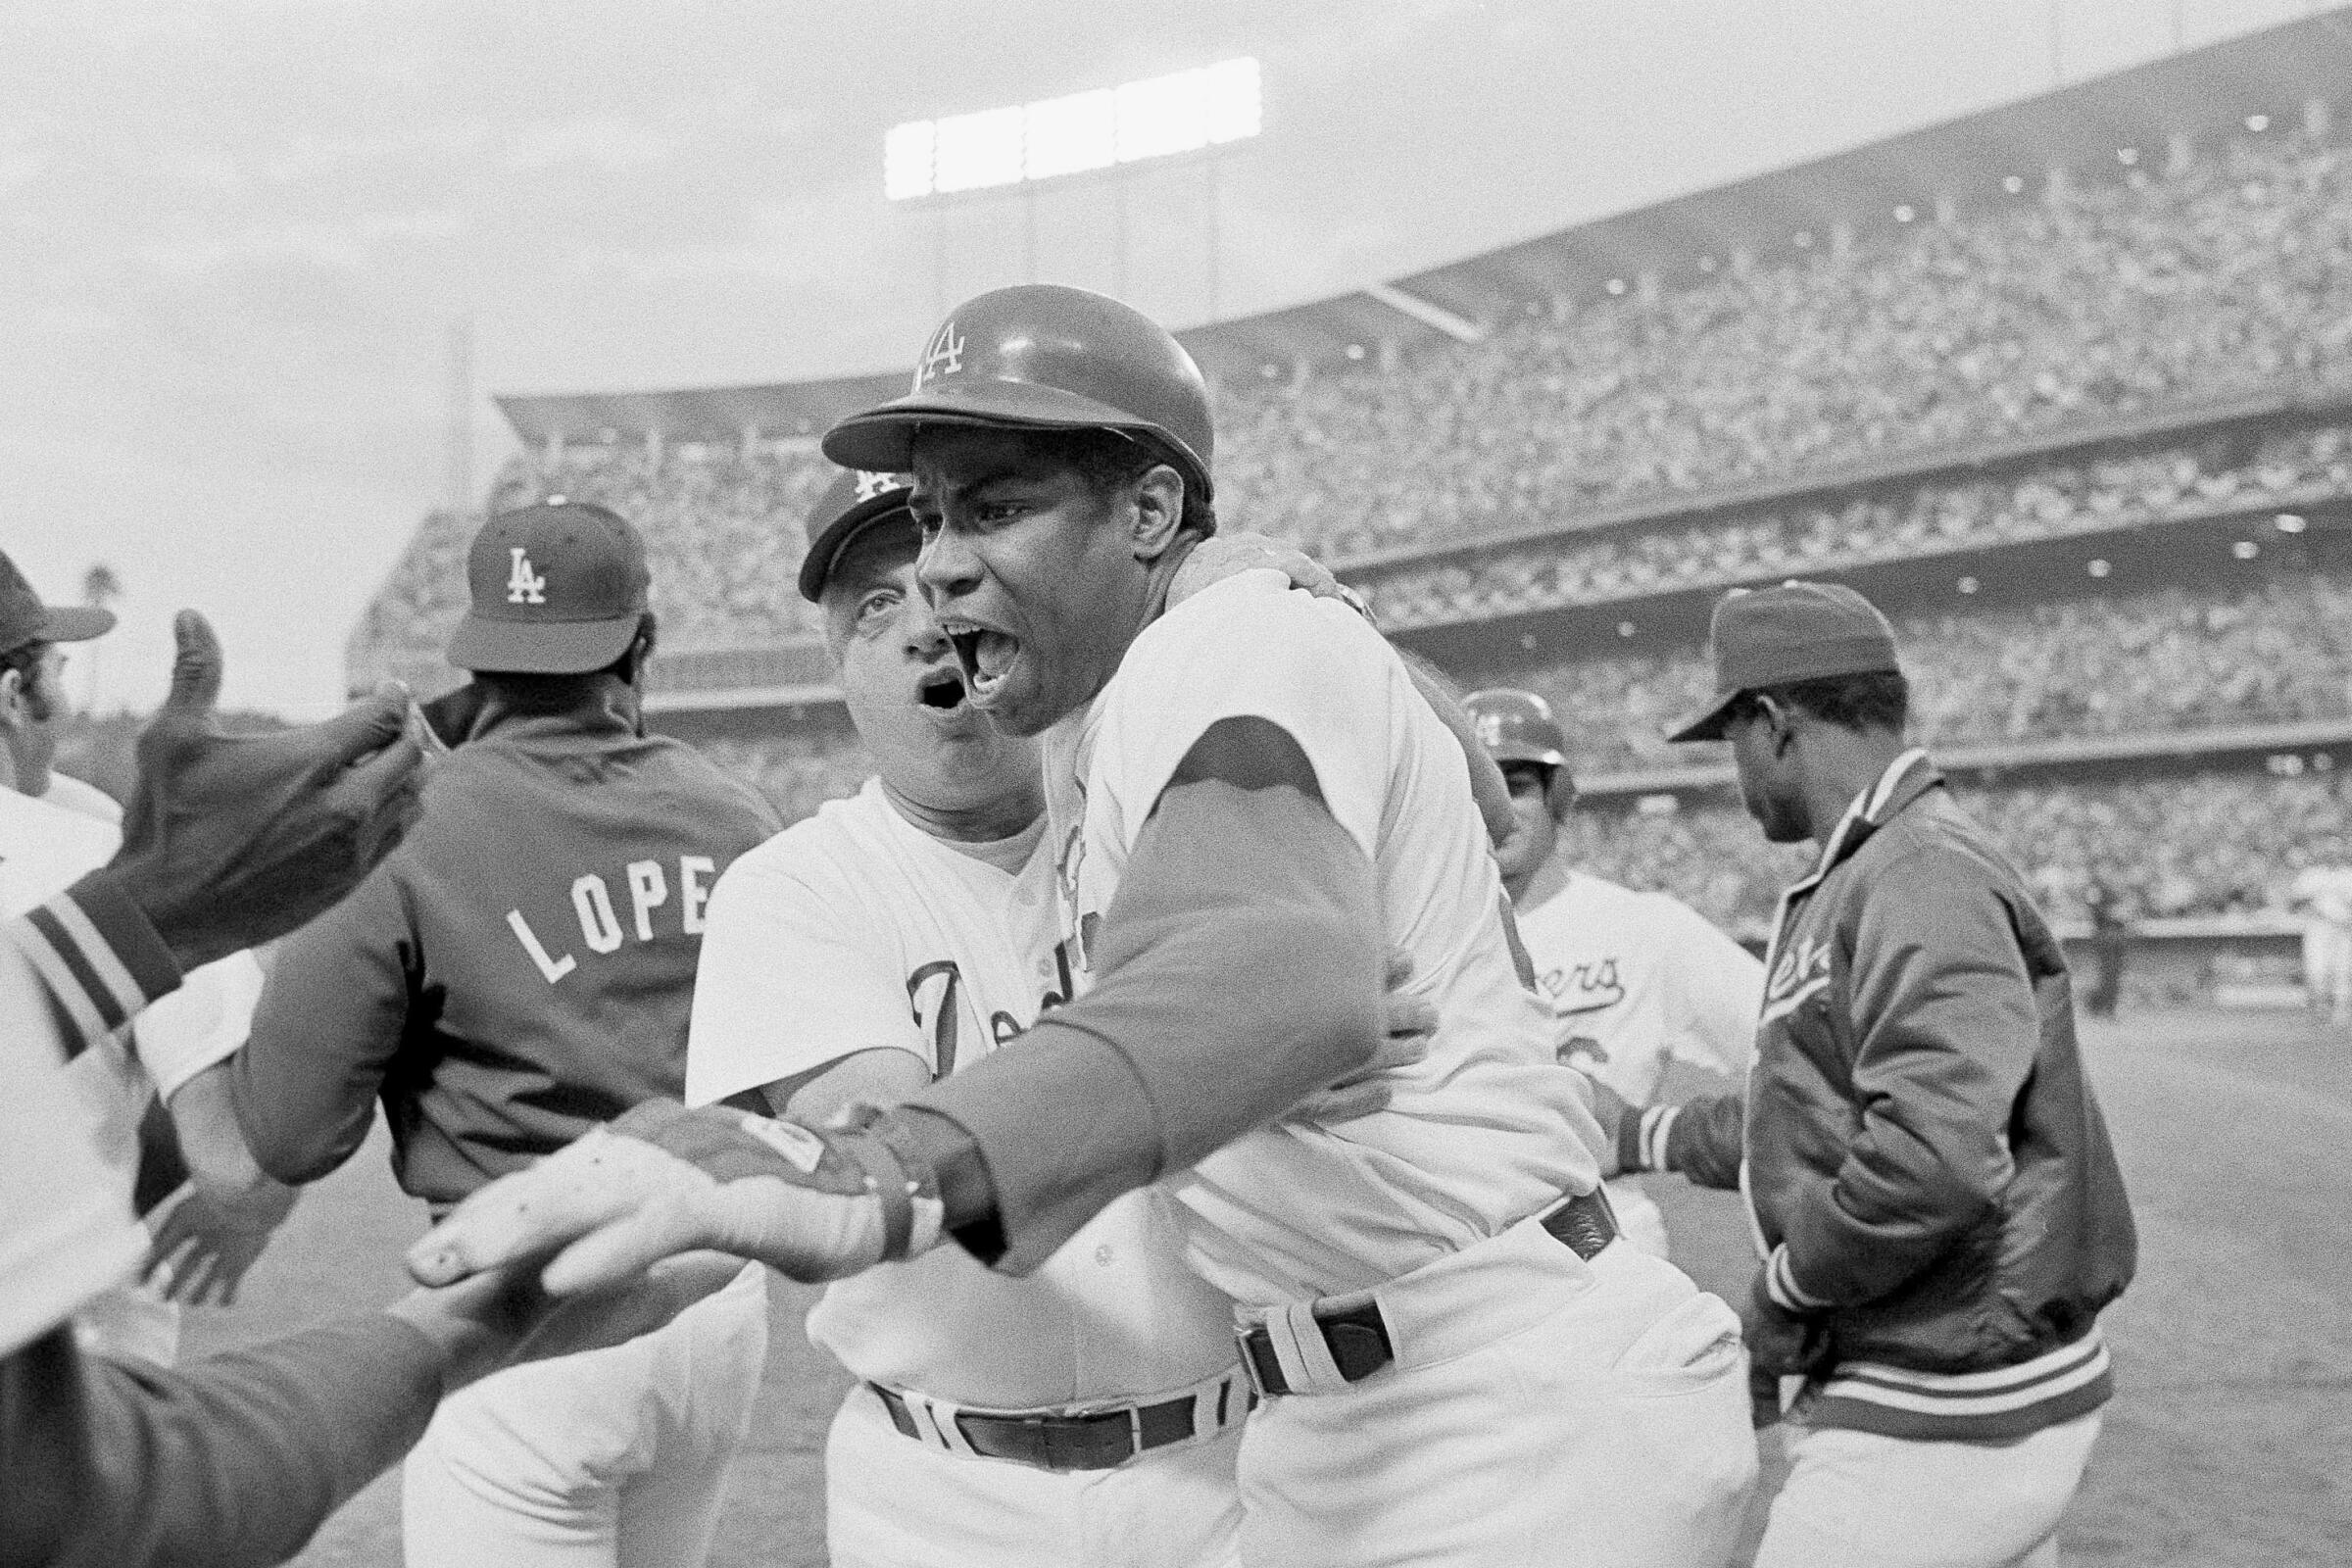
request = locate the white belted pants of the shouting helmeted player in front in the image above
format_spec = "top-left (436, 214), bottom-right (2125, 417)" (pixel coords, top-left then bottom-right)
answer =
top-left (1240, 1220), bottom-right (1757, 1568)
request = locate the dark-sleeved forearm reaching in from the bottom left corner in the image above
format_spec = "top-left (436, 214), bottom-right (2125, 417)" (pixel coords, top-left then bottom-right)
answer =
top-left (0, 1312), bottom-right (445, 1568)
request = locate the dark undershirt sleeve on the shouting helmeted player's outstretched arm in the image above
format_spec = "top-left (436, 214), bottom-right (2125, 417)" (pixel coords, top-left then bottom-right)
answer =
top-left (899, 780), bottom-right (1386, 1272)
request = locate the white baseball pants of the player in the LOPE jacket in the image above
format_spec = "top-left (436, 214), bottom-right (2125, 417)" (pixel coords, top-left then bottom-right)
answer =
top-left (400, 1265), bottom-right (766, 1568)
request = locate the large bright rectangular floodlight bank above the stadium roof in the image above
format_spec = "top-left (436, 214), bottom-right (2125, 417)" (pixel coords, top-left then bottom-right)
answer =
top-left (882, 59), bottom-right (1263, 202)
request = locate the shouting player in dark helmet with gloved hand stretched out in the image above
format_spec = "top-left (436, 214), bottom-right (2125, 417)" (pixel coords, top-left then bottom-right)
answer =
top-left (412, 287), bottom-right (1754, 1566)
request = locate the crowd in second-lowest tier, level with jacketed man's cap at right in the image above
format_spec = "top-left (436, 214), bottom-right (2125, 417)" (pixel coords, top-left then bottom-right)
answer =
top-left (1470, 569), bottom-right (2352, 773)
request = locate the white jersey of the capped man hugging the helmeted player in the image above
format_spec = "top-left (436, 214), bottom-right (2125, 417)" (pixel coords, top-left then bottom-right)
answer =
top-left (687, 780), bottom-right (1235, 1410)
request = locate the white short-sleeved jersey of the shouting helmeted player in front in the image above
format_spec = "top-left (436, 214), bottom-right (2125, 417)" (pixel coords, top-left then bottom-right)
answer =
top-left (1047, 571), bottom-right (1599, 1304)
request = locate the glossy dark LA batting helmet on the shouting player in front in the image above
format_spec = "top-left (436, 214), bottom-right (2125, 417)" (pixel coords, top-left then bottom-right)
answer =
top-left (823, 282), bottom-right (1216, 501)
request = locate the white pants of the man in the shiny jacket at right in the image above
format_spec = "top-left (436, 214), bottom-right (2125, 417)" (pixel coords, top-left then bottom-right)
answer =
top-left (1754, 1410), bottom-right (2100, 1568)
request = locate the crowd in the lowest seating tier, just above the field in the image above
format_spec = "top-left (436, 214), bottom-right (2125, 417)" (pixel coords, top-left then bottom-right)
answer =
top-left (1574, 771), bottom-right (2352, 938)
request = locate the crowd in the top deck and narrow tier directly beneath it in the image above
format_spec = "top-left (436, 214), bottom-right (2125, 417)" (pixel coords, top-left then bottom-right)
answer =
top-left (355, 120), bottom-right (2352, 681)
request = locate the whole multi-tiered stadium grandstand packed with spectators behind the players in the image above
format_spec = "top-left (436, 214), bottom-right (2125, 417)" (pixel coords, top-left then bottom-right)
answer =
top-left (348, 17), bottom-right (2352, 1005)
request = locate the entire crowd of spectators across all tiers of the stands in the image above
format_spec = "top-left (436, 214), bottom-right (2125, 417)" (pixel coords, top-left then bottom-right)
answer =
top-left (331, 131), bottom-right (2352, 945)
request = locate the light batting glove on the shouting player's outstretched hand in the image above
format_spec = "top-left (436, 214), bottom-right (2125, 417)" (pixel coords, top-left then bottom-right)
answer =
top-left (410, 1101), bottom-right (943, 1296)
